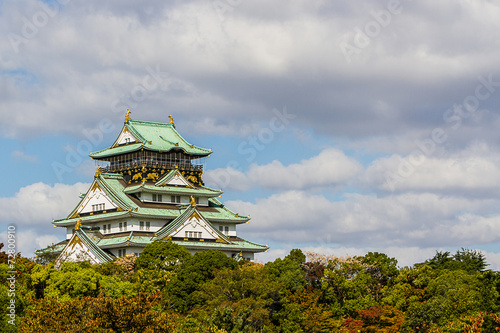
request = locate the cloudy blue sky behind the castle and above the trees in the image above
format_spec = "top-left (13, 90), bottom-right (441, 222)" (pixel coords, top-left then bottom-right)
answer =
top-left (0, 0), bottom-right (500, 270)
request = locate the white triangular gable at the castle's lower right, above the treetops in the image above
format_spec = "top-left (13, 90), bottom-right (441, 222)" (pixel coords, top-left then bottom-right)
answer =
top-left (157, 207), bottom-right (231, 244)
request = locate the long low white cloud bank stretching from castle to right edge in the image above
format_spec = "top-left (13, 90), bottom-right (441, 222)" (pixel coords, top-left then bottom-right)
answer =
top-left (227, 191), bottom-right (500, 247)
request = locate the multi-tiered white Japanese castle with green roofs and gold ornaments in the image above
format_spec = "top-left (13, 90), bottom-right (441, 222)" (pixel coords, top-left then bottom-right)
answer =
top-left (37, 111), bottom-right (268, 265)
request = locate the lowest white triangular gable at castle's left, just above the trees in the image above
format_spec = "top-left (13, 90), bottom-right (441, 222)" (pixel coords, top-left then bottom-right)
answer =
top-left (55, 231), bottom-right (112, 267)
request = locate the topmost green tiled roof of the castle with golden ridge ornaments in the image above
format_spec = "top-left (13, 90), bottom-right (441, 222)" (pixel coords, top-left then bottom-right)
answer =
top-left (89, 119), bottom-right (212, 159)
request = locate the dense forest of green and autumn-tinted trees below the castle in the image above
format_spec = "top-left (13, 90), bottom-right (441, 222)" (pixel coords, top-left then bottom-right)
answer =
top-left (0, 241), bottom-right (500, 333)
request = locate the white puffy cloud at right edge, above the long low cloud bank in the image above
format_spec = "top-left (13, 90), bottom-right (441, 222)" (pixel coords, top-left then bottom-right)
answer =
top-left (364, 143), bottom-right (500, 196)
